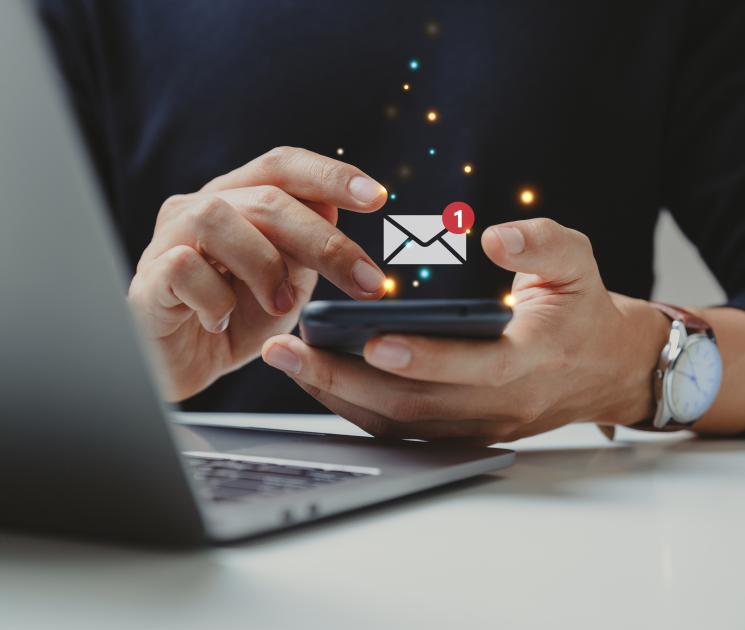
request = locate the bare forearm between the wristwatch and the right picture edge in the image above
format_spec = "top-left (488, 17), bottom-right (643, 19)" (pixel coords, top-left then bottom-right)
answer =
top-left (688, 308), bottom-right (745, 434)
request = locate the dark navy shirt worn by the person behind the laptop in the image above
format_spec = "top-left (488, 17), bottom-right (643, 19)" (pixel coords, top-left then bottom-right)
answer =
top-left (41, 0), bottom-right (745, 411)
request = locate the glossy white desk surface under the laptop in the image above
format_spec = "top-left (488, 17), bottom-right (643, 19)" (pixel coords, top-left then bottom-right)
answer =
top-left (0, 416), bottom-right (745, 630)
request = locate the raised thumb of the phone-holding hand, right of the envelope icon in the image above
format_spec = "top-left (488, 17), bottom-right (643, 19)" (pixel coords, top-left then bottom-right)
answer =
top-left (481, 219), bottom-right (598, 282)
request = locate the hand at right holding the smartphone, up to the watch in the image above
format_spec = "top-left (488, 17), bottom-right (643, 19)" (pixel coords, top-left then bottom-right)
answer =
top-left (262, 219), bottom-right (669, 443)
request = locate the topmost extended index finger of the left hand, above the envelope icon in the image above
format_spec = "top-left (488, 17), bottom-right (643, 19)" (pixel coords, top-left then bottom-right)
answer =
top-left (202, 147), bottom-right (388, 212)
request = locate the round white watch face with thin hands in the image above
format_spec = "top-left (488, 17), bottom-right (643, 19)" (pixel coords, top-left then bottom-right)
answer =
top-left (665, 335), bottom-right (722, 422)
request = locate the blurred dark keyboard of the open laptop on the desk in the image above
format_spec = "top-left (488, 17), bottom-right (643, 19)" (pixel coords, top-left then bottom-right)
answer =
top-left (184, 453), bottom-right (376, 501)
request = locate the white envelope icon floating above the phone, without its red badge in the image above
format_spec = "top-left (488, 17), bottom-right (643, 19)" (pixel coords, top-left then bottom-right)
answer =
top-left (383, 214), bottom-right (466, 265)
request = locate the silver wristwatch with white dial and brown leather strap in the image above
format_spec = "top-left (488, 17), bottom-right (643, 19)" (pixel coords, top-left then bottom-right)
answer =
top-left (633, 302), bottom-right (722, 431)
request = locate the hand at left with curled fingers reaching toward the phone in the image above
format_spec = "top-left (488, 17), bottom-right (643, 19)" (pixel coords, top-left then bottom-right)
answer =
top-left (129, 147), bottom-right (386, 401)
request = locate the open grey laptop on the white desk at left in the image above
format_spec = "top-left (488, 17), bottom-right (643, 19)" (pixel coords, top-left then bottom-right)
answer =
top-left (0, 0), bottom-right (514, 546)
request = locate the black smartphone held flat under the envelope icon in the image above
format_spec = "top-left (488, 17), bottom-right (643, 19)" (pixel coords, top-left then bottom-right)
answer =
top-left (300, 300), bottom-right (512, 354)
